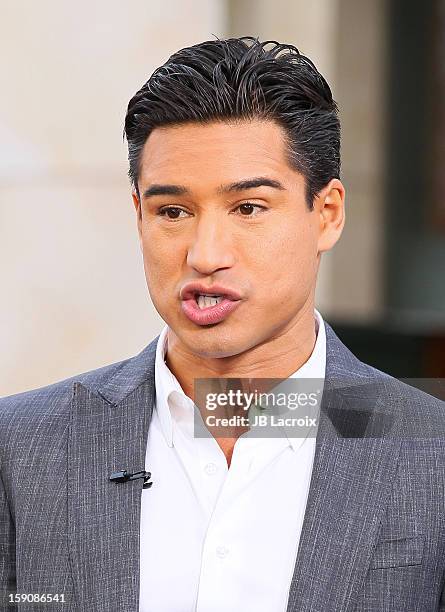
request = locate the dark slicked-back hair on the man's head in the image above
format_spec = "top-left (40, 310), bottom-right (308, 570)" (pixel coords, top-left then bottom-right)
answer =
top-left (124, 36), bottom-right (340, 209)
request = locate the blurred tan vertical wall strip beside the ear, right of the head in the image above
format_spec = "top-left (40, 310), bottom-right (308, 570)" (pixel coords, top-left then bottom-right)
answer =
top-left (326, 0), bottom-right (389, 323)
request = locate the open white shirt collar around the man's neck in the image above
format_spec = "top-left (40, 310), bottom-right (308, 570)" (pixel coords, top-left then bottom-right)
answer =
top-left (155, 310), bottom-right (326, 450)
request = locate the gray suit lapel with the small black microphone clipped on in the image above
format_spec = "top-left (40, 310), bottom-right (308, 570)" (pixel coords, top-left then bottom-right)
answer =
top-left (68, 339), bottom-right (157, 612)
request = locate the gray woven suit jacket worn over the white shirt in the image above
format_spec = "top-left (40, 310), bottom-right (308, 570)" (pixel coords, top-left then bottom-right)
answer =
top-left (0, 324), bottom-right (445, 612)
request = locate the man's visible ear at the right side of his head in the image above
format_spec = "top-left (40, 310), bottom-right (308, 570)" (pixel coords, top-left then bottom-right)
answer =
top-left (314, 179), bottom-right (346, 253)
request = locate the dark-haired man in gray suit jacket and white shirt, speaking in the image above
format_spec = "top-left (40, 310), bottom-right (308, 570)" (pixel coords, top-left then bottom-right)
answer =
top-left (0, 37), bottom-right (445, 612)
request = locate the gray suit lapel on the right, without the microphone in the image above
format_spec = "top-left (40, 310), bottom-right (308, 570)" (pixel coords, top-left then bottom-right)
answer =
top-left (287, 325), bottom-right (401, 612)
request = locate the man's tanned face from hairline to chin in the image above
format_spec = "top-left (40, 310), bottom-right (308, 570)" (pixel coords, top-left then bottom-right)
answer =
top-left (134, 120), bottom-right (332, 358)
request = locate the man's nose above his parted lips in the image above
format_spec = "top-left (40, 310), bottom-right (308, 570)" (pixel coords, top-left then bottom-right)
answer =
top-left (187, 215), bottom-right (235, 275)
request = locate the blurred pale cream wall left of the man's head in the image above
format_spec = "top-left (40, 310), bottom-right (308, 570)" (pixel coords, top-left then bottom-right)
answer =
top-left (0, 0), bottom-right (226, 395)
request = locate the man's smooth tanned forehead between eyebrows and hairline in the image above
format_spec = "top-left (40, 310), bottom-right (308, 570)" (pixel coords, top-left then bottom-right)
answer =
top-left (139, 120), bottom-right (296, 187)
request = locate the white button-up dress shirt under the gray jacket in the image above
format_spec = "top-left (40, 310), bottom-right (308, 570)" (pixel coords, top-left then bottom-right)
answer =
top-left (139, 311), bottom-right (326, 612)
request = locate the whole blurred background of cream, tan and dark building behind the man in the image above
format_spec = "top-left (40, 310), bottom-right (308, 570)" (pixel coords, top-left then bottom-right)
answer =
top-left (0, 0), bottom-right (445, 395)
